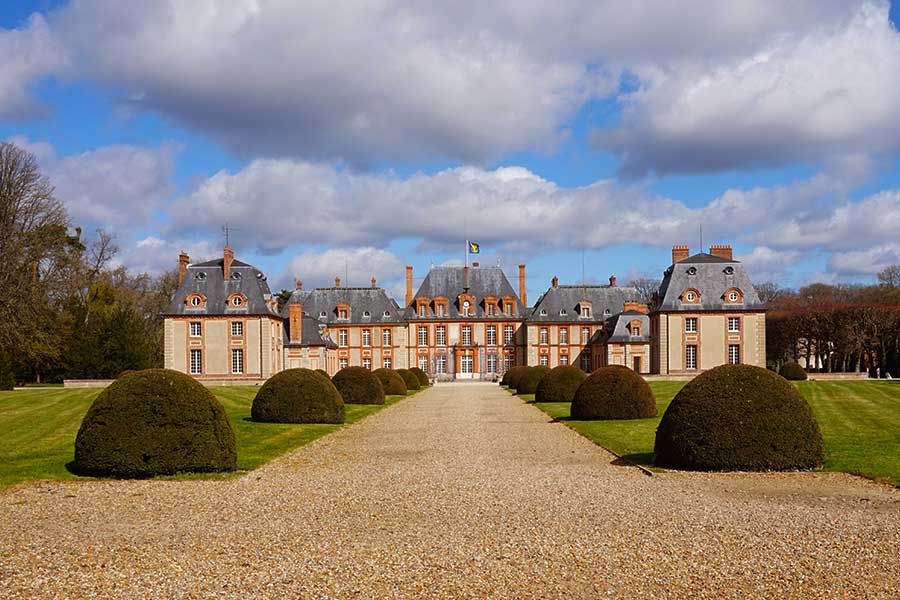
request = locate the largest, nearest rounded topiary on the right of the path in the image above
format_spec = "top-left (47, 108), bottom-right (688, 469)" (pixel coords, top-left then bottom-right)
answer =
top-left (655, 365), bottom-right (825, 471)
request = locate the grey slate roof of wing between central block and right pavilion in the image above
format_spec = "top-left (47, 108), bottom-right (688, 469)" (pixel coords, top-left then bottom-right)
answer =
top-left (528, 285), bottom-right (640, 323)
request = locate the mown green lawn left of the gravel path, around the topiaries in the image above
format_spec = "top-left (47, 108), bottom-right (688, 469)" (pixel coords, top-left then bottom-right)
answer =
top-left (0, 386), bottom-right (414, 489)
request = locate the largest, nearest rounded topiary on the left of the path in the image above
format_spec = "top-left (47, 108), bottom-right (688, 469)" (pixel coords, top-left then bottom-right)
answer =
top-left (75, 369), bottom-right (237, 477)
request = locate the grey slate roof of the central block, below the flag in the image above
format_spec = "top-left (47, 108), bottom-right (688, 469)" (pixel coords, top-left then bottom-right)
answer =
top-left (406, 267), bottom-right (528, 321)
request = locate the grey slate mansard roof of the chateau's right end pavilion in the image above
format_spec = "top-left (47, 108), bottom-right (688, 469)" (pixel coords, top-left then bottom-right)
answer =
top-left (653, 252), bottom-right (765, 312)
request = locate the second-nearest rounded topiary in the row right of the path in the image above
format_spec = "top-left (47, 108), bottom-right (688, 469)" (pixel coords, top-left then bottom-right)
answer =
top-left (571, 365), bottom-right (656, 421)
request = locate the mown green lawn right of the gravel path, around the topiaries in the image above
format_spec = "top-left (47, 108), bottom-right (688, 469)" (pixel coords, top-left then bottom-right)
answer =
top-left (535, 381), bottom-right (900, 485)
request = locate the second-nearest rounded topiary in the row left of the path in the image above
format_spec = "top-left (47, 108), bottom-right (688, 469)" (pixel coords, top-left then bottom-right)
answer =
top-left (250, 369), bottom-right (344, 423)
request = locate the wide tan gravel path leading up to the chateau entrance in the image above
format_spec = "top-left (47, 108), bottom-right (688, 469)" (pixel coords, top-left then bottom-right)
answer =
top-left (0, 384), bottom-right (900, 599)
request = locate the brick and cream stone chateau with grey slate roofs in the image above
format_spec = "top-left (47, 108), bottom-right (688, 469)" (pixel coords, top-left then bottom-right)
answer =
top-left (164, 246), bottom-right (766, 382)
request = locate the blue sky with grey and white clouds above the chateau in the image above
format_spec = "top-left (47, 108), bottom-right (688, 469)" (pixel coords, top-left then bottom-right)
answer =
top-left (0, 0), bottom-right (900, 301)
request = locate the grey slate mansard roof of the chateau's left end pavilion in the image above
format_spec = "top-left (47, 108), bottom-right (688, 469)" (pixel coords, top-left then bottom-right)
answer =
top-left (163, 258), bottom-right (278, 317)
